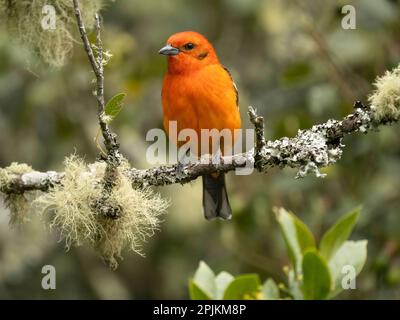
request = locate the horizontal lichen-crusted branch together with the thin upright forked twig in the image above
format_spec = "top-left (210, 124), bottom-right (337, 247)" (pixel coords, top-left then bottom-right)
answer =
top-left (0, 0), bottom-right (400, 204)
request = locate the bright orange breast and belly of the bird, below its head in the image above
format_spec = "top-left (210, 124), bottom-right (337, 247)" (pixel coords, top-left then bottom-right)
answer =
top-left (162, 65), bottom-right (240, 154)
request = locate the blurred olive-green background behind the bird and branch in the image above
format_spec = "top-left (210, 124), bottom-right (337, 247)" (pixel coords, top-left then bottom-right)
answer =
top-left (0, 0), bottom-right (400, 299)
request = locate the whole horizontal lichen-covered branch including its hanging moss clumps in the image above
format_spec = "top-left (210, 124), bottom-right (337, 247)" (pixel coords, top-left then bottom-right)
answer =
top-left (0, 62), bottom-right (400, 269)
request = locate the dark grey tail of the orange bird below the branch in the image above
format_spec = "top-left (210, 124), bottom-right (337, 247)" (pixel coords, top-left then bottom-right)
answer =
top-left (203, 173), bottom-right (232, 220)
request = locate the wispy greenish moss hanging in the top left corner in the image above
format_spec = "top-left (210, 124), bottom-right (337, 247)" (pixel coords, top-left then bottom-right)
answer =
top-left (0, 0), bottom-right (103, 67)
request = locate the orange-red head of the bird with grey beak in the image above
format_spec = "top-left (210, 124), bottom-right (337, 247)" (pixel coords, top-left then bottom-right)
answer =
top-left (159, 31), bottom-right (219, 73)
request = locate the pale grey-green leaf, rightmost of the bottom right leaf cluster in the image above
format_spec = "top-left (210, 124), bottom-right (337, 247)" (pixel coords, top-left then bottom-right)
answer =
top-left (329, 240), bottom-right (367, 298)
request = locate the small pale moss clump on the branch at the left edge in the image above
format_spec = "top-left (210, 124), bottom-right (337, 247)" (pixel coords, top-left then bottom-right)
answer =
top-left (0, 162), bottom-right (33, 226)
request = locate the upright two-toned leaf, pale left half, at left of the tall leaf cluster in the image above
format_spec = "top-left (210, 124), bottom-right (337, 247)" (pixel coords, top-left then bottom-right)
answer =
top-left (275, 208), bottom-right (315, 273)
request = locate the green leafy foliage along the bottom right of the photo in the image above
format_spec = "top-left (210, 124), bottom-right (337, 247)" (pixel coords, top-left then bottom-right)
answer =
top-left (189, 207), bottom-right (367, 300)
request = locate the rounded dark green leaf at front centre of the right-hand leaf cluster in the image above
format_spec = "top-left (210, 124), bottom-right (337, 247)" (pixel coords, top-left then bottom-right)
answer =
top-left (302, 250), bottom-right (331, 300)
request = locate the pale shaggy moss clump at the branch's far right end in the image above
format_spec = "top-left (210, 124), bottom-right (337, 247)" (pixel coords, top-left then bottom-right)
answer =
top-left (368, 66), bottom-right (400, 123)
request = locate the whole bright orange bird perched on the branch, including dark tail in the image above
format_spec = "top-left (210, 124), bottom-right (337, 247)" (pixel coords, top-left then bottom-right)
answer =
top-left (159, 31), bottom-right (240, 219)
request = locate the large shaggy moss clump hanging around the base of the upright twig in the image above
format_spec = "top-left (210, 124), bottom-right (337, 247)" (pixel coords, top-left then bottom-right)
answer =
top-left (33, 156), bottom-right (167, 268)
